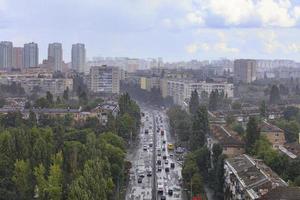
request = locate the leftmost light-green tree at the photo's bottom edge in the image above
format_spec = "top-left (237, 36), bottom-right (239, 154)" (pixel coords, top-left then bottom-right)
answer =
top-left (12, 160), bottom-right (33, 199)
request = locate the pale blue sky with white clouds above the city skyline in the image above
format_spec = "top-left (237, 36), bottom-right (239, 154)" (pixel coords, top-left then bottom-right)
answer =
top-left (0, 0), bottom-right (300, 61)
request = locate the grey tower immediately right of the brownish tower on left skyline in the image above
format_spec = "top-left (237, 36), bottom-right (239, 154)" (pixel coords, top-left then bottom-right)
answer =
top-left (24, 42), bottom-right (39, 68)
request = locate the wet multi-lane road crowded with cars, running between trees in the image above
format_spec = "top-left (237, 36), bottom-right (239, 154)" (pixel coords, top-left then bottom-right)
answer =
top-left (126, 109), bottom-right (182, 200)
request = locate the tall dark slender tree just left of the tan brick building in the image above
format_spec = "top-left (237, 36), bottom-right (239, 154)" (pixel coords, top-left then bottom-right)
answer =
top-left (246, 117), bottom-right (260, 153)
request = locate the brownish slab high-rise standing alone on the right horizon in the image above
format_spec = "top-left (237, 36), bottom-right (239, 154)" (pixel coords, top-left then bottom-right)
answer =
top-left (234, 59), bottom-right (257, 83)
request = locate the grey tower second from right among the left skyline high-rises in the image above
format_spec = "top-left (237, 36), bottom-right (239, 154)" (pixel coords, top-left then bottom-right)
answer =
top-left (48, 43), bottom-right (63, 72)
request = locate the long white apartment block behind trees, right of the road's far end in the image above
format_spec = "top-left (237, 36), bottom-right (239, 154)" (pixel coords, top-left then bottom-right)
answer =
top-left (164, 80), bottom-right (233, 106)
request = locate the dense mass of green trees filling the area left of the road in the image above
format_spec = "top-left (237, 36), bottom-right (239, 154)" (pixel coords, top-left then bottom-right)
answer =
top-left (0, 94), bottom-right (140, 200)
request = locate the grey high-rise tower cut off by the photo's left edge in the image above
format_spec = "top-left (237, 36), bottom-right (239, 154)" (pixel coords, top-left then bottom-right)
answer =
top-left (0, 41), bottom-right (13, 69)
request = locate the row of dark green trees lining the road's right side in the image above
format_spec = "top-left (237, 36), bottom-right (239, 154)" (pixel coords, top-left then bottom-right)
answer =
top-left (167, 91), bottom-right (224, 199)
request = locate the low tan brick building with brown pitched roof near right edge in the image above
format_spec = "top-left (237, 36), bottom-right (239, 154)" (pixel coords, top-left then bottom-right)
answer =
top-left (260, 121), bottom-right (286, 149)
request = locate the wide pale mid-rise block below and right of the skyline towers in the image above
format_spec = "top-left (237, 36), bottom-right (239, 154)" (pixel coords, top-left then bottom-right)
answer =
top-left (89, 65), bottom-right (120, 94)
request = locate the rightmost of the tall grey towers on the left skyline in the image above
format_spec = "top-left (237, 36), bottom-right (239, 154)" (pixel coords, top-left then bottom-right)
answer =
top-left (72, 43), bottom-right (86, 73)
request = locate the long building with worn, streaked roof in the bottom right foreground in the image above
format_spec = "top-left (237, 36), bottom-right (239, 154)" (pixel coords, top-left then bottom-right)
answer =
top-left (224, 154), bottom-right (288, 200)
